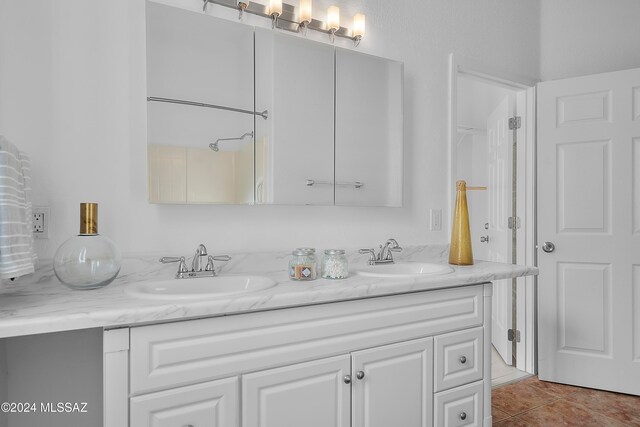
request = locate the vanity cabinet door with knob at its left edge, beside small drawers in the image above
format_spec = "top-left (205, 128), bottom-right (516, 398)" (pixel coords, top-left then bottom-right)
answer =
top-left (352, 338), bottom-right (433, 427)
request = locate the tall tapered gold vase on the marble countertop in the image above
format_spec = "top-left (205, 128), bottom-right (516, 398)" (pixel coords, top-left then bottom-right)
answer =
top-left (449, 181), bottom-right (473, 265)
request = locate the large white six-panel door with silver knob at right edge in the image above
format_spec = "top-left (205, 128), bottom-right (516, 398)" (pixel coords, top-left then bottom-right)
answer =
top-left (537, 69), bottom-right (640, 394)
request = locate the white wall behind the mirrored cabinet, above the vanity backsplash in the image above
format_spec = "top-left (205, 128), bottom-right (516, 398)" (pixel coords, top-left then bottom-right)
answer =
top-left (0, 0), bottom-right (540, 258)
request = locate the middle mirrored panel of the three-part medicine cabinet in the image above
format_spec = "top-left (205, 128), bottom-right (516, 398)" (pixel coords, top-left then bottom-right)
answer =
top-left (256, 28), bottom-right (334, 205)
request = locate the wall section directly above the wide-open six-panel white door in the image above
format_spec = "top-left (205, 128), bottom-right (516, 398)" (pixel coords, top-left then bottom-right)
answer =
top-left (540, 0), bottom-right (640, 80)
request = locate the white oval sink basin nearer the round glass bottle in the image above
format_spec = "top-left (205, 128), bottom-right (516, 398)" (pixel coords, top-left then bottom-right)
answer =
top-left (126, 276), bottom-right (276, 300)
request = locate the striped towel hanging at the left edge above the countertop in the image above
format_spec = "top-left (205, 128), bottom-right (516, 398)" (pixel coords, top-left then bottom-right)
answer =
top-left (0, 135), bottom-right (37, 279)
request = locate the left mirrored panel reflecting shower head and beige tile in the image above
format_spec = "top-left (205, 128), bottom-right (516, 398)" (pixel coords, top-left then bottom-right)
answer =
top-left (147, 2), bottom-right (254, 204)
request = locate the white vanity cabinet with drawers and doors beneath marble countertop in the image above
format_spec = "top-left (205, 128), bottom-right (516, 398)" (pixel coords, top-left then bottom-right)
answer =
top-left (104, 284), bottom-right (491, 427)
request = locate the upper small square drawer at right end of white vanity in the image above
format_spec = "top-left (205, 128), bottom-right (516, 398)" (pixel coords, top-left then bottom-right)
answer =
top-left (434, 327), bottom-right (484, 392)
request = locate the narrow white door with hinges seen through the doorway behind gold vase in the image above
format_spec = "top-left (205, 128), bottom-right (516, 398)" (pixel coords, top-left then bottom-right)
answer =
top-left (487, 95), bottom-right (515, 365)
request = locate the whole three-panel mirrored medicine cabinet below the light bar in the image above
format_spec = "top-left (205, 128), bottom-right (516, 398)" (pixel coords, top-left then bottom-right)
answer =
top-left (147, 2), bottom-right (403, 206)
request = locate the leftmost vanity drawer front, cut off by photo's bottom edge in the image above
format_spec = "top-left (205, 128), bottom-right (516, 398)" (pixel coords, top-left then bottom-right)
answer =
top-left (129, 377), bottom-right (239, 427)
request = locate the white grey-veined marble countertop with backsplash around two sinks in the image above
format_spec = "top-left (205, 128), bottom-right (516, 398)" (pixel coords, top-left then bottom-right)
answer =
top-left (0, 246), bottom-right (538, 338)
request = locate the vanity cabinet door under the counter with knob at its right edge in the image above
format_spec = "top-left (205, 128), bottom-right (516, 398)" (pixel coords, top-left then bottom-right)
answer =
top-left (242, 355), bottom-right (351, 427)
